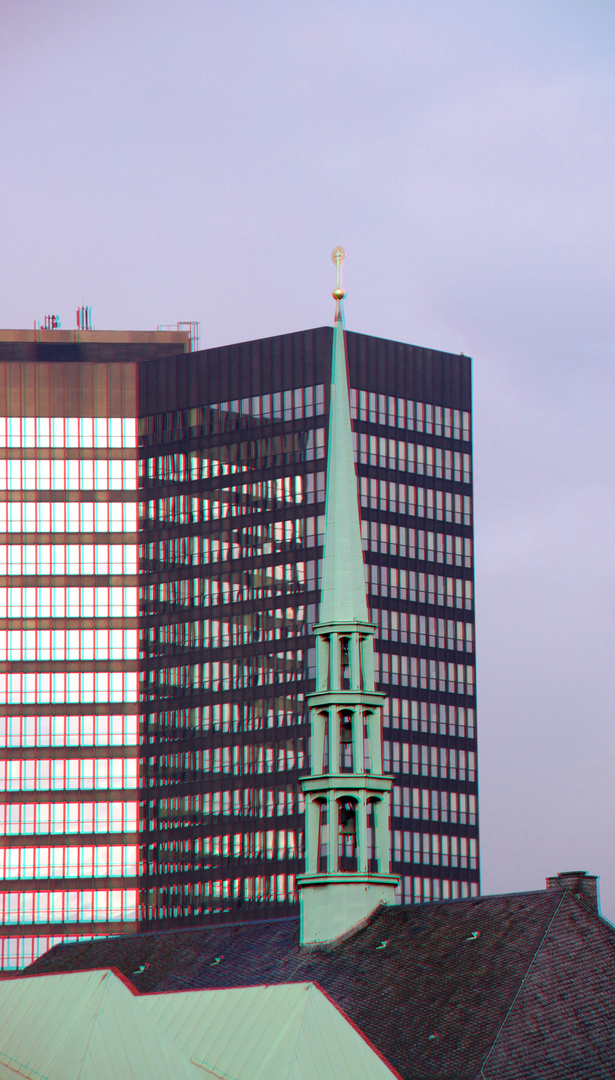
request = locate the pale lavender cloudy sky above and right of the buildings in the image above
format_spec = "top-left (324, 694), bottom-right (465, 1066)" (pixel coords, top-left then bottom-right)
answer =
top-left (0, 0), bottom-right (615, 921)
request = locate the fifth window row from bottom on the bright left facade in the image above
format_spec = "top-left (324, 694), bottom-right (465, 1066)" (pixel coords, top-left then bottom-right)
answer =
top-left (0, 757), bottom-right (138, 792)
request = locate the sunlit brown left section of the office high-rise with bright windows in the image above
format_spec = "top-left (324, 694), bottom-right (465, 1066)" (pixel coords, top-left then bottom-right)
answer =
top-left (0, 321), bottom-right (189, 969)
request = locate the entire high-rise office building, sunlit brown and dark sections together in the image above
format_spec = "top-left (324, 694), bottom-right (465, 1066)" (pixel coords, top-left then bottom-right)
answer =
top-left (0, 304), bottom-right (479, 966)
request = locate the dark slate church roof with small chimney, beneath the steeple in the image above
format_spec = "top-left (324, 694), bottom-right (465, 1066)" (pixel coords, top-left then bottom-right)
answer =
top-left (27, 888), bottom-right (615, 1080)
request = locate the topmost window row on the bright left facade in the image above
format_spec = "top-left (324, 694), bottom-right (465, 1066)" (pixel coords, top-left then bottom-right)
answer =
top-left (0, 416), bottom-right (137, 447)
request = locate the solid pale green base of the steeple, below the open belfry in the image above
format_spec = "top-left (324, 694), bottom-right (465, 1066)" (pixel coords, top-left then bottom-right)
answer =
top-left (297, 873), bottom-right (399, 945)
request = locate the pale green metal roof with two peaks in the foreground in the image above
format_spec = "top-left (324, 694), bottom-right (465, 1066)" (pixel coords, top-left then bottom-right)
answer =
top-left (0, 971), bottom-right (395, 1080)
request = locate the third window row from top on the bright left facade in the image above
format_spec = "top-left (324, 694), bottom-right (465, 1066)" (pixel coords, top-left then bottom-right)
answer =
top-left (0, 502), bottom-right (138, 532)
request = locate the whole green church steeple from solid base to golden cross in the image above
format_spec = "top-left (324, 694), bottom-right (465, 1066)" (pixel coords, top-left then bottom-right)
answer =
top-left (297, 247), bottom-right (399, 945)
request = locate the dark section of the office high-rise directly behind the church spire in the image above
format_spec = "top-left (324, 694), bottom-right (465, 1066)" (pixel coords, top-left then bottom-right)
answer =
top-left (139, 319), bottom-right (479, 927)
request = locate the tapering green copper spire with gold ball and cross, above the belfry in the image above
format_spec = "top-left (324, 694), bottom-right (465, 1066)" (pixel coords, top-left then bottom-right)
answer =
top-left (319, 247), bottom-right (369, 623)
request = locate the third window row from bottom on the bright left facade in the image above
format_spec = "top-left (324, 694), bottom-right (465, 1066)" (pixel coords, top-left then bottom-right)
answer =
top-left (0, 845), bottom-right (138, 880)
